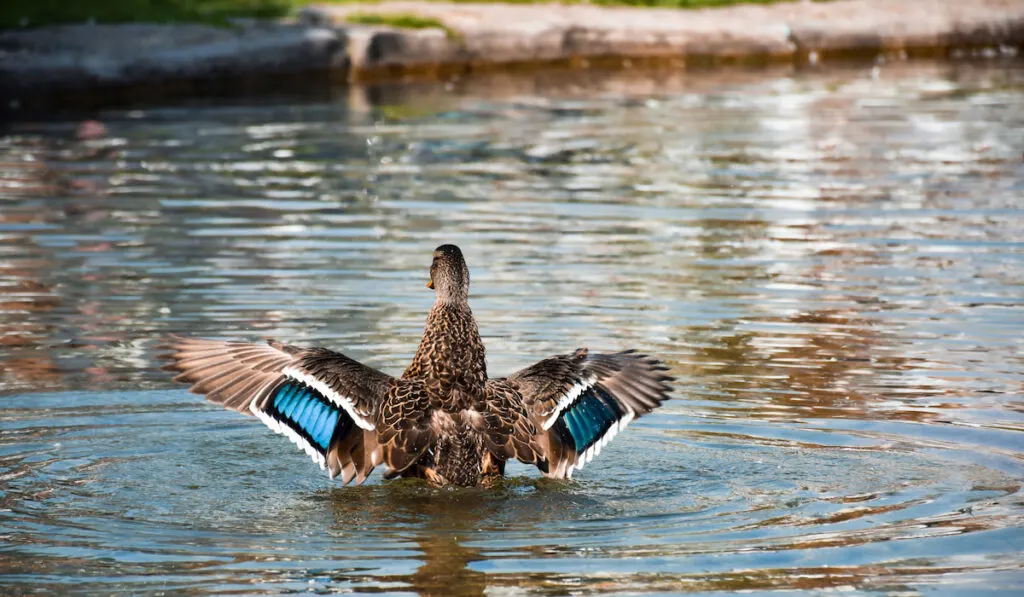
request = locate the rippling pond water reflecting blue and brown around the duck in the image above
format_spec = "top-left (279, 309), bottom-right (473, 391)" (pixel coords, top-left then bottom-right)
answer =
top-left (0, 62), bottom-right (1024, 595)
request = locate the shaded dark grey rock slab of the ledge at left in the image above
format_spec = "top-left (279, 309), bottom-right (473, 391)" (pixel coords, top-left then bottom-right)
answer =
top-left (0, 22), bottom-right (347, 100)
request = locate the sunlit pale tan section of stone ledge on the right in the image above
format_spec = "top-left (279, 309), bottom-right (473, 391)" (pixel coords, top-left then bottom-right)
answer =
top-left (319, 0), bottom-right (1024, 79)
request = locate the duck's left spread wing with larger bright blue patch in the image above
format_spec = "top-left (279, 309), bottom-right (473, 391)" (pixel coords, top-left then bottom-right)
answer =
top-left (164, 336), bottom-right (395, 483)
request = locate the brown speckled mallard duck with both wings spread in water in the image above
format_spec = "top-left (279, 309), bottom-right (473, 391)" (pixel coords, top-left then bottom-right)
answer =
top-left (165, 245), bottom-right (672, 486)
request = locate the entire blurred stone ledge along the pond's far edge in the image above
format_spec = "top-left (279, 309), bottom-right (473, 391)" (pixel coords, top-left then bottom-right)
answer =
top-left (0, 0), bottom-right (1024, 109)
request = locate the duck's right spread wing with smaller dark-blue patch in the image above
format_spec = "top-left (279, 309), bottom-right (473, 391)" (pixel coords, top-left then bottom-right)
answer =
top-left (504, 348), bottom-right (673, 478)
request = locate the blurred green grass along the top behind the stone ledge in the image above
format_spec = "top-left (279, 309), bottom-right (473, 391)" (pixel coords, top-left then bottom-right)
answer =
top-left (0, 0), bottom-right (790, 31)
